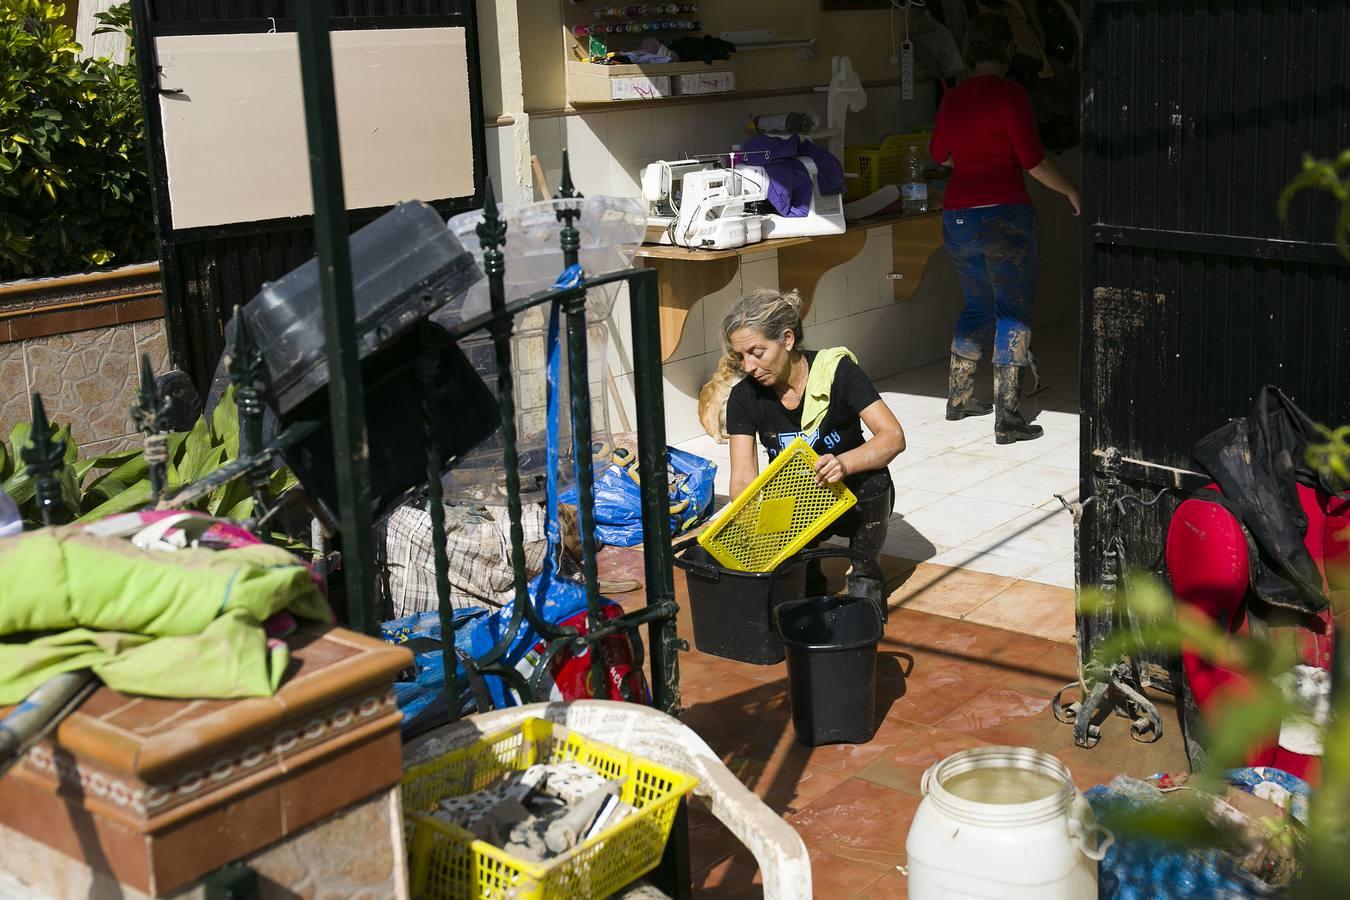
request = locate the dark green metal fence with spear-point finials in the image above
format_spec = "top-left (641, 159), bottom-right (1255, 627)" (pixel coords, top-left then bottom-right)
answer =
top-left (14, 3), bottom-right (684, 719)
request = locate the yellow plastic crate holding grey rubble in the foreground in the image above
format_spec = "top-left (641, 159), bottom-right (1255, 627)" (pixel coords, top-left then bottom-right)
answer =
top-left (402, 719), bottom-right (698, 900)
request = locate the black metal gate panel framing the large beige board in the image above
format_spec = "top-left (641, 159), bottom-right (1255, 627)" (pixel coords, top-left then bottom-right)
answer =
top-left (132, 0), bottom-right (487, 393)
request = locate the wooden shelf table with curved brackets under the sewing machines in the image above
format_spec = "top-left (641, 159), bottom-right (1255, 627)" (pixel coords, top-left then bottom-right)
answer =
top-left (637, 212), bottom-right (942, 360)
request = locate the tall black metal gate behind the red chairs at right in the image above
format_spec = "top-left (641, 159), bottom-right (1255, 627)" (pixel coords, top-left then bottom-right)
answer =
top-left (1077, 0), bottom-right (1350, 739)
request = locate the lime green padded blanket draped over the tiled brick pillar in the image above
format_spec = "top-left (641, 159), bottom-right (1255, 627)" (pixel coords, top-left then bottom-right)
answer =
top-left (0, 526), bottom-right (331, 704)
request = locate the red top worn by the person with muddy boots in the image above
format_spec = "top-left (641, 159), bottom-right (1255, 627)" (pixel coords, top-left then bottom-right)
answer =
top-left (929, 76), bottom-right (1045, 209)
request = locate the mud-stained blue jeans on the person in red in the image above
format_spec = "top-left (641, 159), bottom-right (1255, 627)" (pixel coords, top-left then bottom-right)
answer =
top-left (942, 204), bottom-right (1037, 366)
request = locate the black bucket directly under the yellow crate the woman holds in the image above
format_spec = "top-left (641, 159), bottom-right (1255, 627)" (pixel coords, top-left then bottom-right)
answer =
top-left (675, 542), bottom-right (806, 665)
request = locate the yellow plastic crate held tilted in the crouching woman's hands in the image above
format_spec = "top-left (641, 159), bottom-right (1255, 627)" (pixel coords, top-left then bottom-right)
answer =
top-left (698, 437), bottom-right (857, 572)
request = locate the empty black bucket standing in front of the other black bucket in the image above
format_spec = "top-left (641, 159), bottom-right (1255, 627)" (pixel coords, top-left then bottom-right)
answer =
top-left (774, 595), bottom-right (884, 746)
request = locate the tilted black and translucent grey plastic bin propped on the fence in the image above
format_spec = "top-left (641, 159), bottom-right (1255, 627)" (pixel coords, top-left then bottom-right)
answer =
top-left (207, 202), bottom-right (501, 522)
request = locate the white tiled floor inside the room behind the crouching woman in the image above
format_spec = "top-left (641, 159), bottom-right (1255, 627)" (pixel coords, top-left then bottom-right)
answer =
top-left (679, 324), bottom-right (1079, 588)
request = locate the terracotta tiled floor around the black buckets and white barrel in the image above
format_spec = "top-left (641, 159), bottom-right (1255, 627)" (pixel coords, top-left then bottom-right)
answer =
top-left (658, 560), bottom-right (1185, 900)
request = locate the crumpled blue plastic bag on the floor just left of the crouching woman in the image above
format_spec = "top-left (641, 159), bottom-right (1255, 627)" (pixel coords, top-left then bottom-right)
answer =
top-left (562, 447), bottom-right (717, 546)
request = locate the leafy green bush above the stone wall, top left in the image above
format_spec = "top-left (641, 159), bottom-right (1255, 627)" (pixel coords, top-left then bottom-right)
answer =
top-left (0, 0), bottom-right (155, 279)
